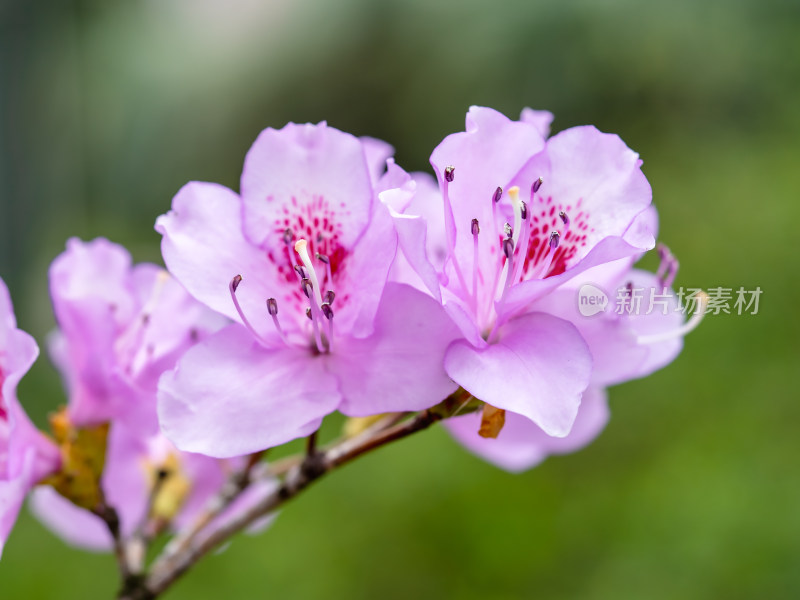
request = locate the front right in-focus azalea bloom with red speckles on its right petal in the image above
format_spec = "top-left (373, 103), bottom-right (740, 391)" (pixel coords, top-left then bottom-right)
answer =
top-left (399, 107), bottom-right (654, 437)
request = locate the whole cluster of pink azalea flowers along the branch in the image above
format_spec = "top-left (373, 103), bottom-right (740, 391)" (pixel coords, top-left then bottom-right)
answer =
top-left (0, 107), bottom-right (703, 572)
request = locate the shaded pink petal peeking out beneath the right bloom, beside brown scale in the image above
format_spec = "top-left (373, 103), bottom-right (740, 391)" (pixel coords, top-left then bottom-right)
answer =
top-left (445, 387), bottom-right (609, 473)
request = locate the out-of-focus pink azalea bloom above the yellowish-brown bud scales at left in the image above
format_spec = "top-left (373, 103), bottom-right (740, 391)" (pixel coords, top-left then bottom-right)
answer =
top-left (50, 238), bottom-right (224, 435)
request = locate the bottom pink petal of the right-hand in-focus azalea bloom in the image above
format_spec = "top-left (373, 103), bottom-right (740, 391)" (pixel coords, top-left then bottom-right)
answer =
top-left (444, 313), bottom-right (592, 437)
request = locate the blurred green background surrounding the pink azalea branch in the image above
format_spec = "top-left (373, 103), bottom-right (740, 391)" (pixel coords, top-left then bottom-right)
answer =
top-left (0, 0), bottom-right (800, 600)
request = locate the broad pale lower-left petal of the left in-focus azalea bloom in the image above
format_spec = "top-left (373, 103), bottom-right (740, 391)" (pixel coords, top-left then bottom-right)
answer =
top-left (158, 324), bottom-right (340, 458)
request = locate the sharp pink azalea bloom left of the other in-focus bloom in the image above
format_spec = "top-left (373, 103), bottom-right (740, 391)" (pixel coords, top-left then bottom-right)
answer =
top-left (156, 123), bottom-right (458, 457)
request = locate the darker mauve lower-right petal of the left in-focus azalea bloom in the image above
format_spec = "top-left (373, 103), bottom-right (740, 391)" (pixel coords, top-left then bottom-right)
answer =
top-left (329, 283), bottom-right (460, 416)
